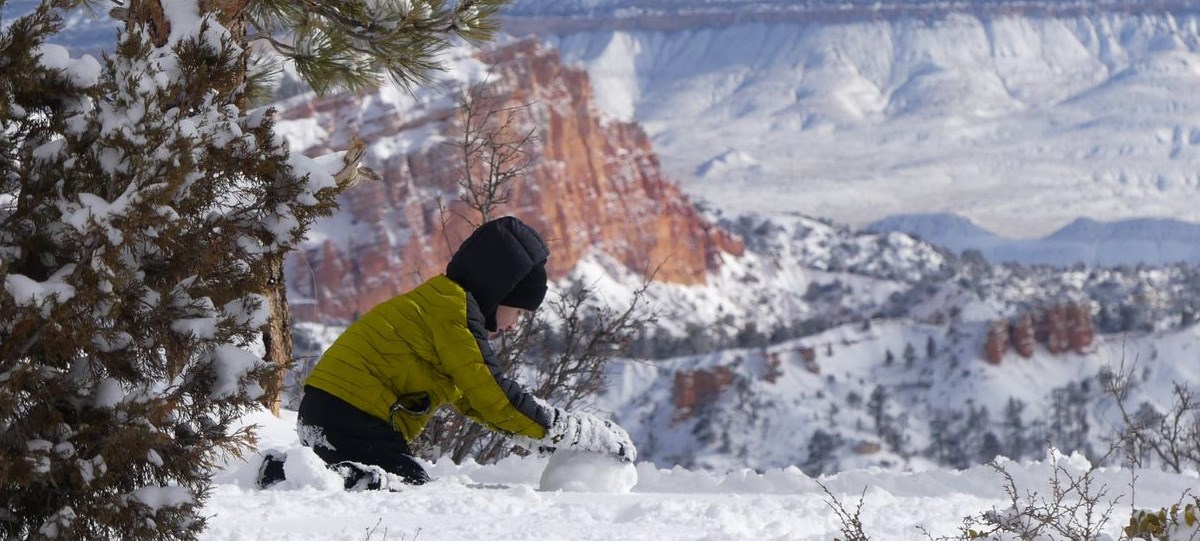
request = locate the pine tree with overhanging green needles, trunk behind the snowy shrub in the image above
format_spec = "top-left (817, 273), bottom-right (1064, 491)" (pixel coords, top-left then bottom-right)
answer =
top-left (114, 0), bottom-right (508, 414)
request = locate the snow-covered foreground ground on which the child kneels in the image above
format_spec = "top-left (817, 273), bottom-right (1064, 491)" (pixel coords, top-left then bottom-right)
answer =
top-left (202, 411), bottom-right (1198, 541)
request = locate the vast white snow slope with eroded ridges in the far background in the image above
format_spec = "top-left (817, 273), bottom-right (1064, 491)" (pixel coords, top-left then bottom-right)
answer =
top-left (532, 9), bottom-right (1200, 238)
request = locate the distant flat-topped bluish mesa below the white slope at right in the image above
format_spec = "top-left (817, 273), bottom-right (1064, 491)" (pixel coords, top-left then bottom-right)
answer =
top-left (868, 214), bottom-right (1200, 266)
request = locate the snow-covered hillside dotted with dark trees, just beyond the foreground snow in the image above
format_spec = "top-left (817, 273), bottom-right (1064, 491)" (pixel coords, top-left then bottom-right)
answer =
top-left (598, 320), bottom-right (1200, 474)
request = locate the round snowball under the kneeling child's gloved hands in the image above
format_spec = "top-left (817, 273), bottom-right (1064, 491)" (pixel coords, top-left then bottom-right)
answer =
top-left (539, 450), bottom-right (637, 493)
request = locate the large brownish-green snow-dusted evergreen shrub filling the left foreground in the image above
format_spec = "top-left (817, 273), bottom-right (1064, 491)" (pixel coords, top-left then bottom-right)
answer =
top-left (0, 0), bottom-right (343, 540)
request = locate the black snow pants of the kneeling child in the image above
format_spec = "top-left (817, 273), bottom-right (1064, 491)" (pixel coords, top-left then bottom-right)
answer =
top-left (298, 386), bottom-right (430, 488)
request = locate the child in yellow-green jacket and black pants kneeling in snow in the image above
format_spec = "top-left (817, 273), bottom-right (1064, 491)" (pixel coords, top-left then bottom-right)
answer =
top-left (259, 217), bottom-right (637, 488)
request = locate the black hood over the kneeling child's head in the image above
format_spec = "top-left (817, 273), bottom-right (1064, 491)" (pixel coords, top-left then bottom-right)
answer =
top-left (446, 216), bottom-right (550, 332)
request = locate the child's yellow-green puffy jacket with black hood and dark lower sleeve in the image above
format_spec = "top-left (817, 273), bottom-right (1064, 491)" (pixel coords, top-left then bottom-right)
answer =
top-left (305, 218), bottom-right (553, 440)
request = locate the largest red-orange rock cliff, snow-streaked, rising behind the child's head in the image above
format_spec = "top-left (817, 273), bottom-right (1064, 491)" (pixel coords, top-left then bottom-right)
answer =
top-left (282, 40), bottom-right (743, 320)
